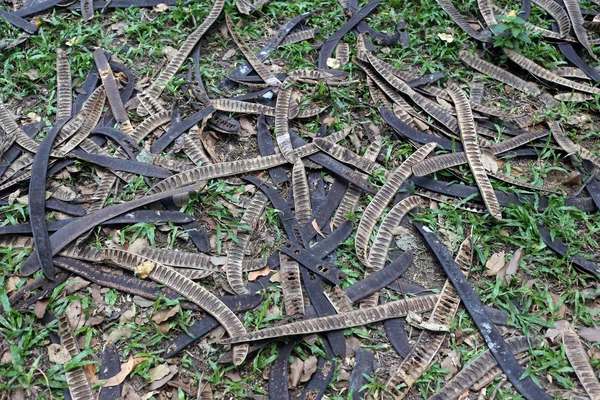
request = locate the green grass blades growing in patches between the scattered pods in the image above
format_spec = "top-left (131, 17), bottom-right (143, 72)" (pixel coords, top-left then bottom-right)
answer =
top-left (0, 0), bottom-right (600, 400)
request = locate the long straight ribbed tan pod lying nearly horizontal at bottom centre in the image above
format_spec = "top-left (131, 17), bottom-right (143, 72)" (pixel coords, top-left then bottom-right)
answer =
top-left (221, 294), bottom-right (438, 344)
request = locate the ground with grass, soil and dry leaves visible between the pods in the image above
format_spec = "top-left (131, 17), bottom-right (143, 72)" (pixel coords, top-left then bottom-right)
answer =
top-left (0, 0), bottom-right (600, 399)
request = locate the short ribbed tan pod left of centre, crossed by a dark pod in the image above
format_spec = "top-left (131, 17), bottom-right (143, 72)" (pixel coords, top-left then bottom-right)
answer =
top-left (227, 191), bottom-right (267, 294)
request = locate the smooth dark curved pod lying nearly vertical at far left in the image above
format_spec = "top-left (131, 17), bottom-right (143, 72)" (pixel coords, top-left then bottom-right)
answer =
top-left (29, 119), bottom-right (67, 280)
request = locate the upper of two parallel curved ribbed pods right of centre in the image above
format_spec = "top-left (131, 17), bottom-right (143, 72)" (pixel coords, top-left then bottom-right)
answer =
top-left (354, 143), bottom-right (437, 262)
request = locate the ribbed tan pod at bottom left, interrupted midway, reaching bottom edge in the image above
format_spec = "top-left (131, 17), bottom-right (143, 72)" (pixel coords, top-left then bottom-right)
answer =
top-left (56, 313), bottom-right (96, 400)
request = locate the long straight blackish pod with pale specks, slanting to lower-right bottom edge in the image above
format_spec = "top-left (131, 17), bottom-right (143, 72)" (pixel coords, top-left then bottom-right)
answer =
top-left (415, 223), bottom-right (551, 400)
